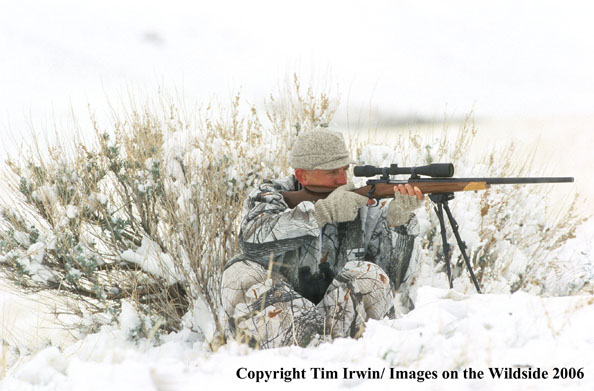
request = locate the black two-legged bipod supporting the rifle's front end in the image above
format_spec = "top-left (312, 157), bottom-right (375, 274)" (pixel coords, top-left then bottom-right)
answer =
top-left (429, 193), bottom-right (481, 293)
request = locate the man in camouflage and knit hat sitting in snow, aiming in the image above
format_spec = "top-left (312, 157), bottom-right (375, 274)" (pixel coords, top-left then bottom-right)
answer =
top-left (221, 130), bottom-right (423, 348)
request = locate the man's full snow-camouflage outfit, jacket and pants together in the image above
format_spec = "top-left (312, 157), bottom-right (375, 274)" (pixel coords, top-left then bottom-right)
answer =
top-left (221, 176), bottom-right (418, 347)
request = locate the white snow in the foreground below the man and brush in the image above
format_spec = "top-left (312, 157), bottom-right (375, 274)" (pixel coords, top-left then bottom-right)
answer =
top-left (0, 287), bottom-right (594, 390)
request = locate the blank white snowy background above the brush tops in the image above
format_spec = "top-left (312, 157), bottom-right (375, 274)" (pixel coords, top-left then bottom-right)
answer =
top-left (0, 0), bottom-right (594, 134)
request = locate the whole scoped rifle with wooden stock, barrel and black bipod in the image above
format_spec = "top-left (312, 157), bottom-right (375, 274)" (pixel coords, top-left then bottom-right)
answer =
top-left (282, 163), bottom-right (573, 293)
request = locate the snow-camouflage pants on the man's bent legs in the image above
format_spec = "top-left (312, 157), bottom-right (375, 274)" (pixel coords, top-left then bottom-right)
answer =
top-left (222, 261), bottom-right (393, 348)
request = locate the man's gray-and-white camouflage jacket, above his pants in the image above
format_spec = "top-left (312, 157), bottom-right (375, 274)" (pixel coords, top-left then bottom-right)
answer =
top-left (228, 176), bottom-right (418, 293)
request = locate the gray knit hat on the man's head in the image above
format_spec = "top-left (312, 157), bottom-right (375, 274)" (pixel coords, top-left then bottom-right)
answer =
top-left (289, 129), bottom-right (356, 170)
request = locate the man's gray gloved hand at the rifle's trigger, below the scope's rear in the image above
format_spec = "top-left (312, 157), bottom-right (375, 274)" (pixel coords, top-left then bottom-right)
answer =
top-left (314, 183), bottom-right (369, 228)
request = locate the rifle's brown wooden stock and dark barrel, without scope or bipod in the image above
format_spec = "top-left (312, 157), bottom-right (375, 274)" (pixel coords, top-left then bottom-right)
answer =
top-left (283, 177), bottom-right (573, 209)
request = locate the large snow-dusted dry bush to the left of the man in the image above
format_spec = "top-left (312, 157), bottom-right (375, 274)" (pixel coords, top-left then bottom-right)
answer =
top-left (0, 78), bottom-right (333, 348)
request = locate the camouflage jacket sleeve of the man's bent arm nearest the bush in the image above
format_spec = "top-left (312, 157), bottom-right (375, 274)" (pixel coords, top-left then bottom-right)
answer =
top-left (240, 183), bottom-right (320, 259)
